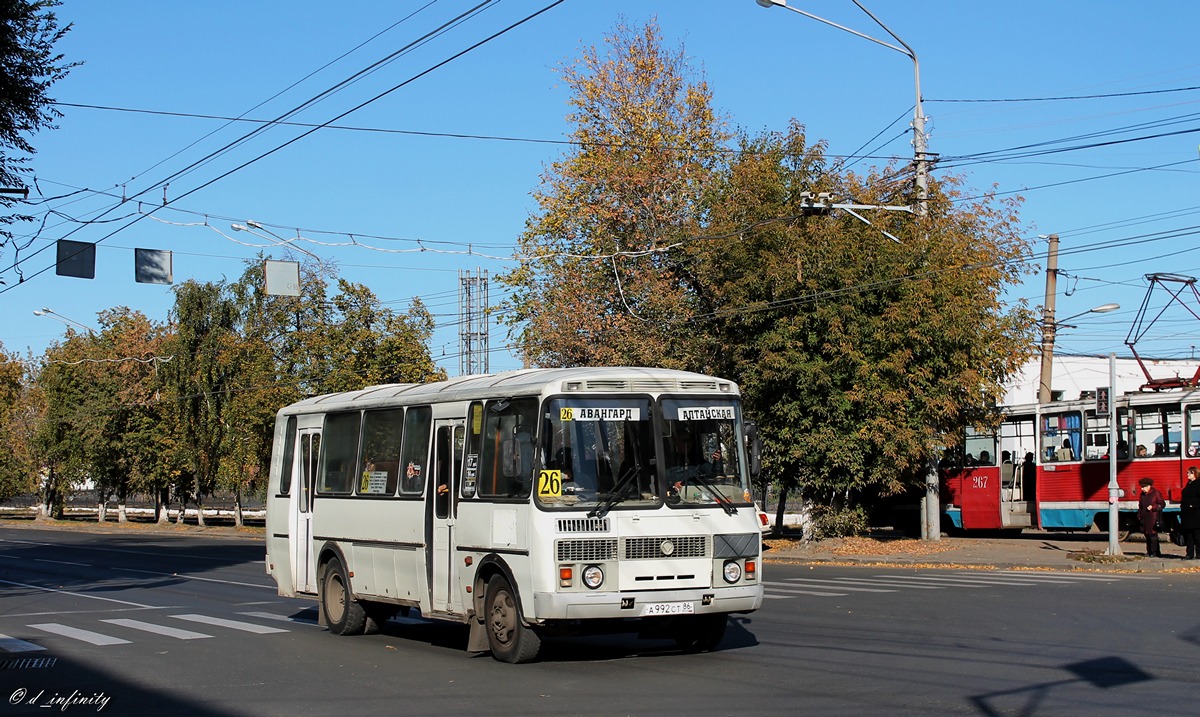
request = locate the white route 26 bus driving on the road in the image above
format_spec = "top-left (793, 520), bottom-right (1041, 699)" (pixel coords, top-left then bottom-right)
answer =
top-left (266, 368), bottom-right (763, 662)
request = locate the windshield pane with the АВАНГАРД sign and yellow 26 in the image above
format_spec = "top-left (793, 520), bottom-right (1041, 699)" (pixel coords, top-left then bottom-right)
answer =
top-left (536, 398), bottom-right (660, 512)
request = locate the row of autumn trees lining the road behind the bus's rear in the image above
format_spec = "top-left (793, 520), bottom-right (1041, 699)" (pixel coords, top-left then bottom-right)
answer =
top-left (0, 258), bottom-right (445, 524)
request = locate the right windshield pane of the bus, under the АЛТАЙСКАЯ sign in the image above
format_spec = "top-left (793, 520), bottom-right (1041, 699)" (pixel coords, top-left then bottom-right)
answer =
top-left (662, 398), bottom-right (750, 512)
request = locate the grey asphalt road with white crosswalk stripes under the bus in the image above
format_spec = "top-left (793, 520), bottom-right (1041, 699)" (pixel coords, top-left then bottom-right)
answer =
top-left (0, 528), bottom-right (1200, 717)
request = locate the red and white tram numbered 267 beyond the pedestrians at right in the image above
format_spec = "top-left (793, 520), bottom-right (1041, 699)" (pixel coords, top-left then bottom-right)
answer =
top-left (940, 388), bottom-right (1200, 532)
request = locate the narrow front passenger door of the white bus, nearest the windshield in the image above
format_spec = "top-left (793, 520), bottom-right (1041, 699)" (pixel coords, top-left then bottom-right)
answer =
top-left (426, 420), bottom-right (466, 613)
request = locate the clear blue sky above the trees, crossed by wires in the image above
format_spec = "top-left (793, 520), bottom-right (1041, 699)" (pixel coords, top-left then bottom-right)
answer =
top-left (0, 0), bottom-right (1200, 375)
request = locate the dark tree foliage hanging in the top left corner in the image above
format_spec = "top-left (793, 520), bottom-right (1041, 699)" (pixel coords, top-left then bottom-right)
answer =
top-left (0, 0), bottom-right (76, 246)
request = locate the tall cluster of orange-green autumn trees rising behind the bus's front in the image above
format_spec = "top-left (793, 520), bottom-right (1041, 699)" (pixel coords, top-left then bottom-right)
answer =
top-left (500, 23), bottom-right (1034, 534)
